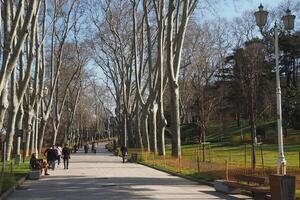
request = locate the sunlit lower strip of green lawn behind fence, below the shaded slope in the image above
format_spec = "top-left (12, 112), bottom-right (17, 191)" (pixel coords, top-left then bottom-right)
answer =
top-left (178, 143), bottom-right (300, 167)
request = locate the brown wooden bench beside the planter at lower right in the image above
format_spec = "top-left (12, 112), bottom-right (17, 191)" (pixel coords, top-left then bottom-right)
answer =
top-left (224, 174), bottom-right (270, 200)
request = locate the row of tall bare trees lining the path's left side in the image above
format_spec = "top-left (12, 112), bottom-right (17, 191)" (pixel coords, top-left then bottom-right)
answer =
top-left (0, 0), bottom-right (96, 160)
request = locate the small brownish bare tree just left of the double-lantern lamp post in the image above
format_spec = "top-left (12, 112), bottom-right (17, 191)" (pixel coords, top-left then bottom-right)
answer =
top-left (226, 40), bottom-right (271, 169)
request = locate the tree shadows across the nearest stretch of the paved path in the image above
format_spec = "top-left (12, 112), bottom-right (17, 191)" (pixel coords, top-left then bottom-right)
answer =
top-left (8, 176), bottom-right (246, 200)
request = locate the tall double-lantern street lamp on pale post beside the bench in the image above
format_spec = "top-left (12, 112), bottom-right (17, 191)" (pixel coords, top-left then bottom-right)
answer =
top-left (254, 4), bottom-right (296, 175)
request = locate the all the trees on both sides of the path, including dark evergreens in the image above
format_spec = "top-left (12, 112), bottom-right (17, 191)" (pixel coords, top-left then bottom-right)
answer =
top-left (0, 0), bottom-right (299, 170)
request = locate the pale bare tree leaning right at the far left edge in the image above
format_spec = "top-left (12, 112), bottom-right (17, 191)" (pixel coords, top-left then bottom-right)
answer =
top-left (0, 0), bottom-right (39, 133)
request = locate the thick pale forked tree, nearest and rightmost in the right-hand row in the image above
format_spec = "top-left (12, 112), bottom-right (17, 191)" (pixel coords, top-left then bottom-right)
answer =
top-left (166, 0), bottom-right (198, 156)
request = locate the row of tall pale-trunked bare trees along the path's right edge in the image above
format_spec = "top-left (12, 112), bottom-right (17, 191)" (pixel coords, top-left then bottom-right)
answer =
top-left (91, 0), bottom-right (197, 156)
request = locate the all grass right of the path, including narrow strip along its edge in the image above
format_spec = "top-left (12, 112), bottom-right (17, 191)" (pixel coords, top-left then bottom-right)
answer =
top-left (129, 120), bottom-right (300, 200)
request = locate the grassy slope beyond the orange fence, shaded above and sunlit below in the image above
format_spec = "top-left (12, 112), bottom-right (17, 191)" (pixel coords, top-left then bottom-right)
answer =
top-left (178, 121), bottom-right (300, 167)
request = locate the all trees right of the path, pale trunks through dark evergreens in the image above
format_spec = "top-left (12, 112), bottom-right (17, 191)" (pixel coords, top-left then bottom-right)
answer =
top-left (90, 0), bottom-right (299, 170)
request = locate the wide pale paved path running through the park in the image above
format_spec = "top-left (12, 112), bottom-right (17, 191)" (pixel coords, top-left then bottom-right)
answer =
top-left (8, 145), bottom-right (249, 200)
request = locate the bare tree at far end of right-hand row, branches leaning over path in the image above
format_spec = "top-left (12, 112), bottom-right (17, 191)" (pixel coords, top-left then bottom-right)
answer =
top-left (91, 1), bottom-right (135, 148)
